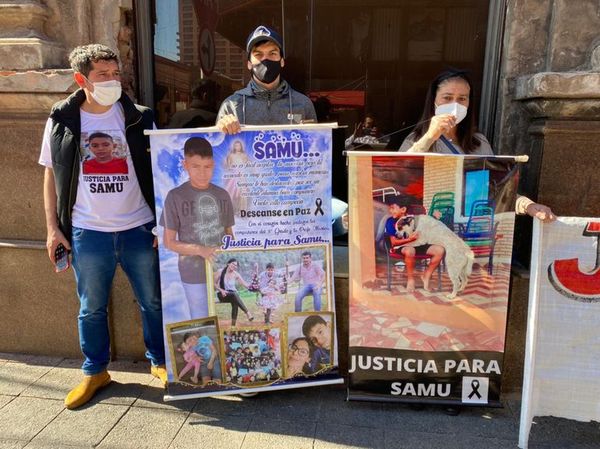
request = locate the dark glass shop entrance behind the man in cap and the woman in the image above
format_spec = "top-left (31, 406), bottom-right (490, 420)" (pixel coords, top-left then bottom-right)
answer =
top-left (137, 0), bottom-right (505, 203)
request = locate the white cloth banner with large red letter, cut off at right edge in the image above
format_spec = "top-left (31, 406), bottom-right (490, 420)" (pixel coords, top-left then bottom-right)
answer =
top-left (519, 217), bottom-right (600, 448)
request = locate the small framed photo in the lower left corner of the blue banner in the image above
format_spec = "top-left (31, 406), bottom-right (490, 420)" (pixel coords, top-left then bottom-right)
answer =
top-left (167, 317), bottom-right (222, 385)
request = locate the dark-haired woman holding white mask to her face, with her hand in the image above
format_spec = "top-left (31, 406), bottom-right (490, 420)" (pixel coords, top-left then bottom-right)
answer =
top-left (399, 69), bottom-right (556, 222)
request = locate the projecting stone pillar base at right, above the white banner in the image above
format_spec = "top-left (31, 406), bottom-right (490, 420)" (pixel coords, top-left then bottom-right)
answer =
top-left (515, 70), bottom-right (600, 260)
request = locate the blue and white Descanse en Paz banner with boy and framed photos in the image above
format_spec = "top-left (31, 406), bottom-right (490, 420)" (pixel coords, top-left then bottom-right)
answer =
top-left (147, 125), bottom-right (342, 400)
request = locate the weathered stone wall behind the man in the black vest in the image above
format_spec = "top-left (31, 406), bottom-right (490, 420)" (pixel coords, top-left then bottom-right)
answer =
top-left (0, 0), bottom-right (144, 357)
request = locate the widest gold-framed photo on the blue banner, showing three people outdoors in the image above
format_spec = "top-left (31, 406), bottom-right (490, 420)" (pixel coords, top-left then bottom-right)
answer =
top-left (207, 245), bottom-right (332, 329)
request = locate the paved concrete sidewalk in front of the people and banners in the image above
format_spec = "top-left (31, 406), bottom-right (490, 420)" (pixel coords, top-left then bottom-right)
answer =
top-left (0, 354), bottom-right (600, 449)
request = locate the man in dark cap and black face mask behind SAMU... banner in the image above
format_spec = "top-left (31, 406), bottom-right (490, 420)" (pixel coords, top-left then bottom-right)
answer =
top-left (216, 25), bottom-right (317, 134)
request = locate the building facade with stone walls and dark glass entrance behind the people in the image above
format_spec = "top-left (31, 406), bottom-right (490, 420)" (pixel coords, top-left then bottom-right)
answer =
top-left (0, 0), bottom-right (600, 389)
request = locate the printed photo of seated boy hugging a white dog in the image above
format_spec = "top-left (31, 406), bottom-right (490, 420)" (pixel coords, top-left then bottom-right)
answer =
top-left (350, 156), bottom-right (516, 351)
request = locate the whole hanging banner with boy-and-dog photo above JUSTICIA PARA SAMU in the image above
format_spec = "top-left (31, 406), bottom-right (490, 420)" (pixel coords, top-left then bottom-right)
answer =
top-left (347, 151), bottom-right (517, 406)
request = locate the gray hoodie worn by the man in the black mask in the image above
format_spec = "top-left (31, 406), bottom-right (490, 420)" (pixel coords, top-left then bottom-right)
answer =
top-left (217, 79), bottom-right (317, 125)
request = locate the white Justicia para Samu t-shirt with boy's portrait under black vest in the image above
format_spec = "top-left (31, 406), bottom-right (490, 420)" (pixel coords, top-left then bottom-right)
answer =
top-left (39, 103), bottom-right (154, 232)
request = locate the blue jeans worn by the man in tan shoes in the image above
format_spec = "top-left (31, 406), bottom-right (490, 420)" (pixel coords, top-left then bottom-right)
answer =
top-left (71, 223), bottom-right (165, 375)
